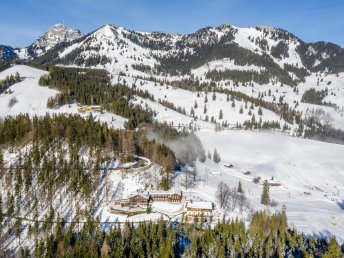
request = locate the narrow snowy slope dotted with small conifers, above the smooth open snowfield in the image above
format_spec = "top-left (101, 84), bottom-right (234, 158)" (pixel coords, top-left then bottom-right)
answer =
top-left (113, 74), bottom-right (291, 131)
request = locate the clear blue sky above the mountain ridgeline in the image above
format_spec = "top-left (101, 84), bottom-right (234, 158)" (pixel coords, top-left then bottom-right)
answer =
top-left (0, 0), bottom-right (344, 47)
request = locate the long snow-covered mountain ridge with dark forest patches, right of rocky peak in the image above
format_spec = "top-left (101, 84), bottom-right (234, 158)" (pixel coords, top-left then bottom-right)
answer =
top-left (22, 24), bottom-right (344, 86)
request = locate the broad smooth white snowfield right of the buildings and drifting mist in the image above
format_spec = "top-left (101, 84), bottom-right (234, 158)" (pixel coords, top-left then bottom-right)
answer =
top-left (193, 130), bottom-right (344, 241)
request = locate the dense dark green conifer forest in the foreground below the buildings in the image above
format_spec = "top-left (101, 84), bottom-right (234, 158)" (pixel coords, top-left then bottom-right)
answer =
top-left (14, 211), bottom-right (343, 258)
